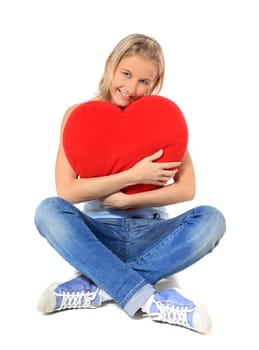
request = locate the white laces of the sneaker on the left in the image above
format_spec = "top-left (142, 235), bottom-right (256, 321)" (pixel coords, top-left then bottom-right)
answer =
top-left (56, 289), bottom-right (99, 310)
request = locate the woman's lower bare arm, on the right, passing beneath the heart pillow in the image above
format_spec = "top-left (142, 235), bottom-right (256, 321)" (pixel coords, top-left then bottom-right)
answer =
top-left (101, 151), bottom-right (195, 209)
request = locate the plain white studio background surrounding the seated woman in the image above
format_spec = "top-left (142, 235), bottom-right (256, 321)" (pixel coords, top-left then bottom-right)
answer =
top-left (0, 0), bottom-right (259, 349)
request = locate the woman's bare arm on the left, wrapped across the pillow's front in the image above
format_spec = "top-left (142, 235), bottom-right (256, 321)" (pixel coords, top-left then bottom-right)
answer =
top-left (55, 106), bottom-right (180, 203)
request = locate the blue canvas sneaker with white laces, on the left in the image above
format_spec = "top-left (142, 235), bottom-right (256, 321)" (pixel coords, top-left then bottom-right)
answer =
top-left (38, 275), bottom-right (102, 313)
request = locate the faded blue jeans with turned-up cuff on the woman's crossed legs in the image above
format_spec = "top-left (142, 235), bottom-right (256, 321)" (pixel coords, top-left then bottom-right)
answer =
top-left (35, 197), bottom-right (225, 317)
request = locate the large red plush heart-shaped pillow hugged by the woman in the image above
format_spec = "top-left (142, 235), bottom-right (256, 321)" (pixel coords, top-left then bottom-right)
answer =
top-left (63, 95), bottom-right (188, 193)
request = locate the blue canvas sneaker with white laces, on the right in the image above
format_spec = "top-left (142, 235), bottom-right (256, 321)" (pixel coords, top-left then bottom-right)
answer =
top-left (147, 288), bottom-right (212, 334)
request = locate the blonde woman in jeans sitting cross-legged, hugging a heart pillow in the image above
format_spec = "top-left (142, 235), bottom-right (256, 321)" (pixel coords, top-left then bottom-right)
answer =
top-left (35, 34), bottom-right (225, 333)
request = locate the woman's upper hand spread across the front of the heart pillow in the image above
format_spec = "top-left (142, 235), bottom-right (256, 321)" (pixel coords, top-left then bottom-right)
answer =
top-left (130, 150), bottom-right (181, 186)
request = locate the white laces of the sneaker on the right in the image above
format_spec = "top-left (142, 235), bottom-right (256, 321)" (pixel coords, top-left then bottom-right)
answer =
top-left (147, 301), bottom-right (195, 329)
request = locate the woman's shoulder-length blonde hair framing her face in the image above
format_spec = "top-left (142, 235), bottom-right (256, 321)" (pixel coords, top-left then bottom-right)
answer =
top-left (98, 34), bottom-right (165, 100)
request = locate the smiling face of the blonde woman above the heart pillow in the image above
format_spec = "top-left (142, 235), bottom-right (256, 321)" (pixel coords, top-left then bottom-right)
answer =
top-left (110, 55), bottom-right (158, 107)
